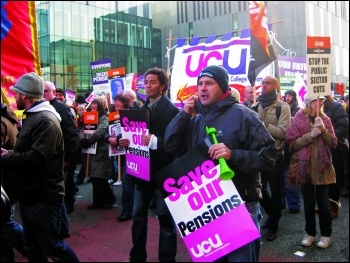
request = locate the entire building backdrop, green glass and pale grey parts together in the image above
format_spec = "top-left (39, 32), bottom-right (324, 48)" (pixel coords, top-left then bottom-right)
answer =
top-left (36, 1), bottom-right (349, 97)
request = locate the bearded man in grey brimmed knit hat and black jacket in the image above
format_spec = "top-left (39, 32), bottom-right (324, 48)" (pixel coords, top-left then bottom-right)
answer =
top-left (1, 72), bottom-right (79, 262)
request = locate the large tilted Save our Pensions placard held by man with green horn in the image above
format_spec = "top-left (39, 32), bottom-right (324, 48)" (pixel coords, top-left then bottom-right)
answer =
top-left (154, 142), bottom-right (260, 262)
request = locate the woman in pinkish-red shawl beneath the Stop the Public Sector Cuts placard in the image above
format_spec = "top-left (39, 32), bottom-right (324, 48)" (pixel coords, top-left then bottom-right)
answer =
top-left (286, 97), bottom-right (337, 248)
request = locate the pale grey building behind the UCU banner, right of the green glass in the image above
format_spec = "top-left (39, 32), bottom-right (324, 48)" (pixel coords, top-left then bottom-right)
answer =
top-left (152, 1), bottom-right (349, 93)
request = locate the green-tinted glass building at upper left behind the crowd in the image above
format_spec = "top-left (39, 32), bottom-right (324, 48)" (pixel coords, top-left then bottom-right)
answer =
top-left (36, 1), bottom-right (162, 95)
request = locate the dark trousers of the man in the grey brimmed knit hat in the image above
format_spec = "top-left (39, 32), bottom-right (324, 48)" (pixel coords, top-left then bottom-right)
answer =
top-left (20, 203), bottom-right (79, 262)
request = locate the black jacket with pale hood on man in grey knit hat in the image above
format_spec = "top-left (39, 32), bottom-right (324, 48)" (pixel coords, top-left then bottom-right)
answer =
top-left (1, 101), bottom-right (65, 204)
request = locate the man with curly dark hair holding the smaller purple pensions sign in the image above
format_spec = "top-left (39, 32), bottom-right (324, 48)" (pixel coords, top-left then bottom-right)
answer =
top-left (119, 68), bottom-right (179, 262)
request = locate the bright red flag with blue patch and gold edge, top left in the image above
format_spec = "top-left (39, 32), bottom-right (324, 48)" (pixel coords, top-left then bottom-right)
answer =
top-left (1, 1), bottom-right (41, 109)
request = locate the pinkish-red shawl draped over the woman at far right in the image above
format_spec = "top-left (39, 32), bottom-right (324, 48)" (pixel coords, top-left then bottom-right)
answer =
top-left (286, 111), bottom-right (334, 186)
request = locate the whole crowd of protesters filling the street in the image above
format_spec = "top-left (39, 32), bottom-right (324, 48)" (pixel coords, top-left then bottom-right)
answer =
top-left (1, 66), bottom-right (349, 262)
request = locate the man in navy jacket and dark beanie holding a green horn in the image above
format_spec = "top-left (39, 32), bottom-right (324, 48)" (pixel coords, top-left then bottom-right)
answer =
top-left (164, 66), bottom-right (276, 262)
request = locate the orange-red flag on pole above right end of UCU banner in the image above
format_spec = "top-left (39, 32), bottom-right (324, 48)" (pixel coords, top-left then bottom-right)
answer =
top-left (248, 1), bottom-right (276, 87)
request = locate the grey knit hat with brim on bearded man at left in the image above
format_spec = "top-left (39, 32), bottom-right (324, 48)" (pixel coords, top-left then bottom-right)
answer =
top-left (10, 72), bottom-right (44, 99)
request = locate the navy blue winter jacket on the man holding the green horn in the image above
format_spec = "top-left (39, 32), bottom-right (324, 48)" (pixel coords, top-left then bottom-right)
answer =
top-left (164, 96), bottom-right (277, 202)
